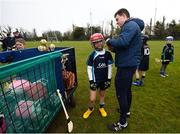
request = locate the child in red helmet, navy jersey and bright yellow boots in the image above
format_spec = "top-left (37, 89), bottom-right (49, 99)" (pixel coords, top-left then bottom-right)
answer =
top-left (83, 33), bottom-right (113, 119)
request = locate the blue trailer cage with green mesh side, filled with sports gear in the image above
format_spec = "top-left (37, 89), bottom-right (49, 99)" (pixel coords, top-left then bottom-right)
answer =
top-left (0, 47), bottom-right (78, 133)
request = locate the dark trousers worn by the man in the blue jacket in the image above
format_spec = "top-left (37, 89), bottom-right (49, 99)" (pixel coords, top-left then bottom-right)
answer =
top-left (115, 67), bottom-right (136, 124)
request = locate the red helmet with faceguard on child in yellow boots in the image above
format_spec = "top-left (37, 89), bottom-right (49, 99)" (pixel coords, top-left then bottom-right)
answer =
top-left (90, 33), bottom-right (104, 51)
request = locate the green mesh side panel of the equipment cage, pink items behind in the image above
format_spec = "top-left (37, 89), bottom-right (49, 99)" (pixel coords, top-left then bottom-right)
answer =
top-left (0, 51), bottom-right (60, 133)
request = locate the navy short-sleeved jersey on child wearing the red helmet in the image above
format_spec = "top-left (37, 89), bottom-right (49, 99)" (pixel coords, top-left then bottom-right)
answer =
top-left (87, 50), bottom-right (113, 83)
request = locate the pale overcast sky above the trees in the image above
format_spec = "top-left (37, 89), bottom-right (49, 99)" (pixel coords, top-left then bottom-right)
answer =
top-left (0, 0), bottom-right (180, 33)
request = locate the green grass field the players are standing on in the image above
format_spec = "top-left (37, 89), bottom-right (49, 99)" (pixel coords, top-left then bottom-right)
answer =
top-left (13, 41), bottom-right (180, 133)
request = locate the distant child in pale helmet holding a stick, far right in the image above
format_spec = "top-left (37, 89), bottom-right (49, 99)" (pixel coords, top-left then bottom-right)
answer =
top-left (160, 36), bottom-right (174, 77)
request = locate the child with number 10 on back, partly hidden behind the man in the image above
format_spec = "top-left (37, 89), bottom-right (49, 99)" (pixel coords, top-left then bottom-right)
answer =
top-left (132, 35), bottom-right (150, 86)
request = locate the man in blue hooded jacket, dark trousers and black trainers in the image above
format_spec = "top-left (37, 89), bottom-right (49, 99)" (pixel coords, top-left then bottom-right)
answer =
top-left (106, 8), bottom-right (144, 131)
